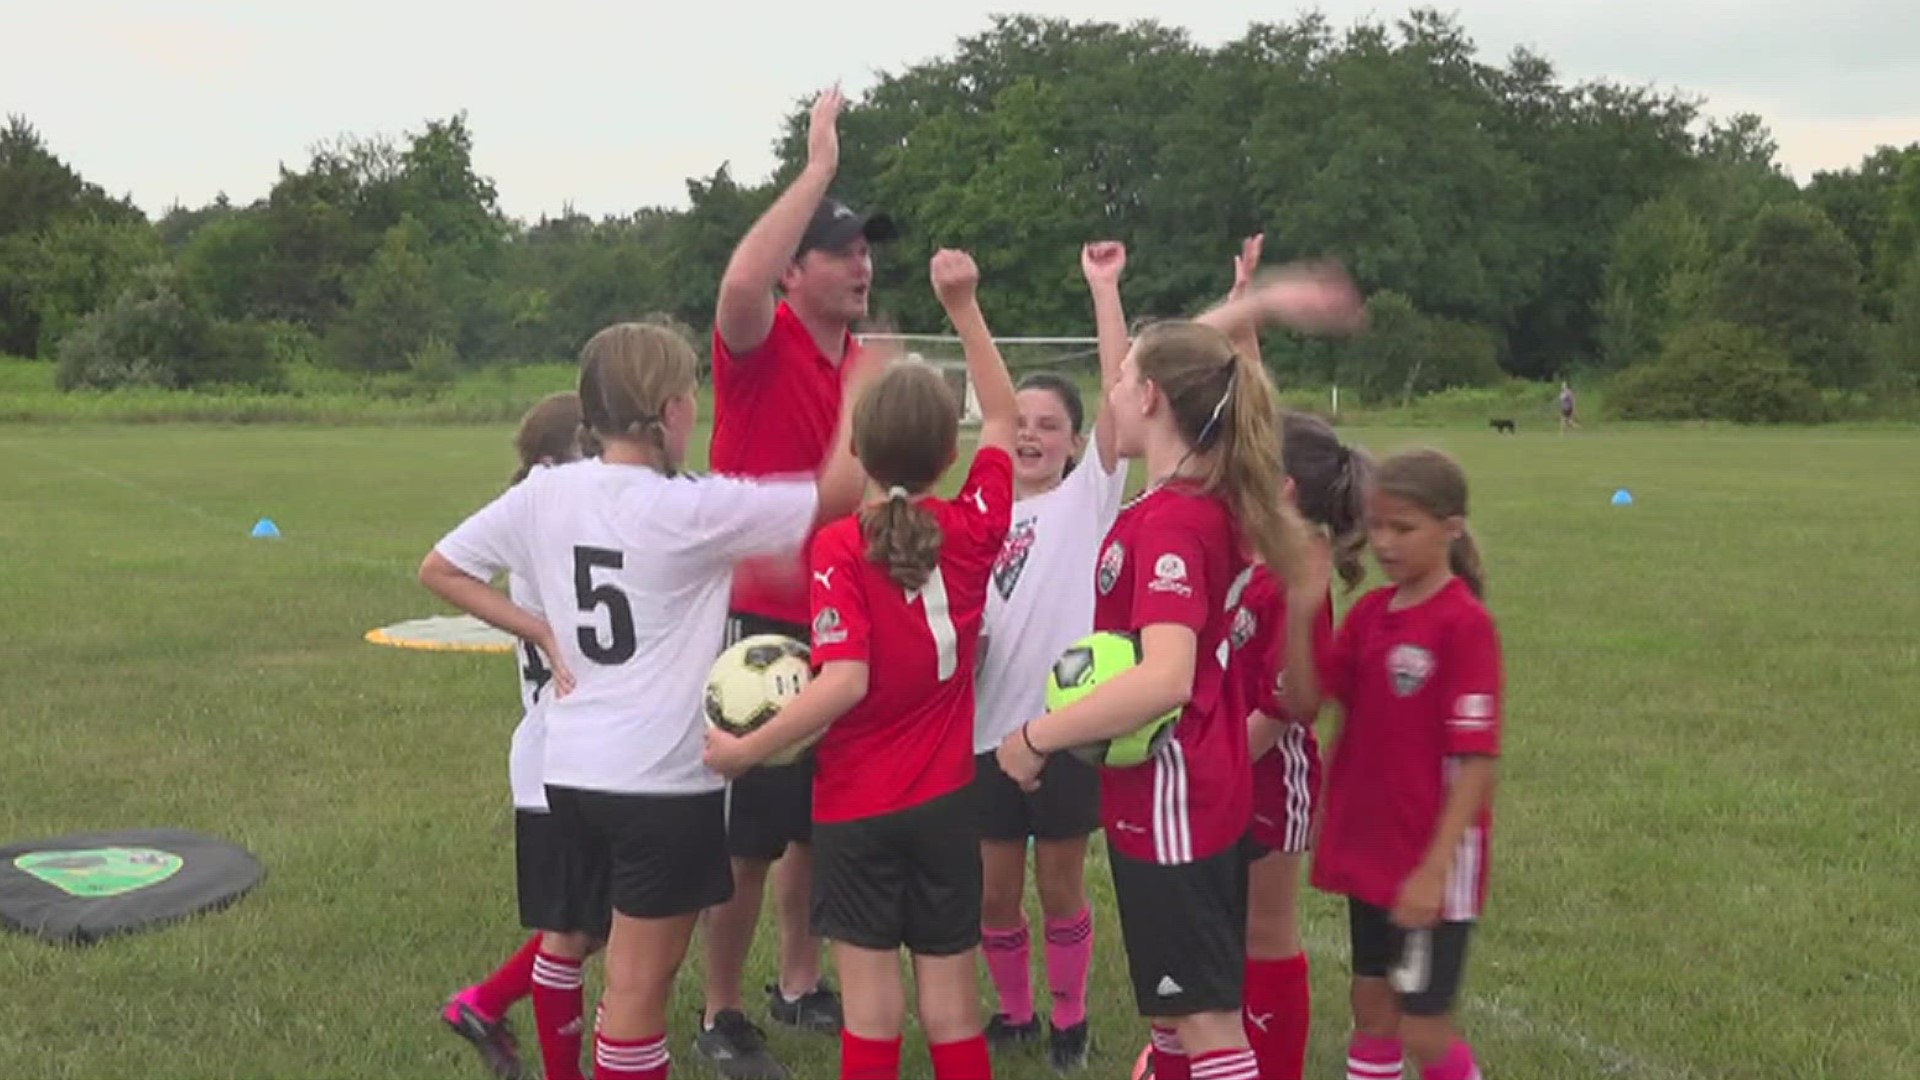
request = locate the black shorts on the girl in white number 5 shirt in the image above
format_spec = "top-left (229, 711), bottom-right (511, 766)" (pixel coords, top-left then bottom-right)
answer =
top-left (547, 784), bottom-right (733, 922)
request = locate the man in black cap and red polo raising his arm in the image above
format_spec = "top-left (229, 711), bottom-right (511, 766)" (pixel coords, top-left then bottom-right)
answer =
top-left (695, 88), bottom-right (893, 1080)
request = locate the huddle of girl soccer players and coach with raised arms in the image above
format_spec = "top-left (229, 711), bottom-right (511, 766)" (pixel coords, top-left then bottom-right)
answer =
top-left (420, 90), bottom-right (1501, 1080)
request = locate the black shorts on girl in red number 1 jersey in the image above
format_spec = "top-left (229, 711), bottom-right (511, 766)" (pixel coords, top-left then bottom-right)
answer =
top-left (812, 788), bottom-right (981, 957)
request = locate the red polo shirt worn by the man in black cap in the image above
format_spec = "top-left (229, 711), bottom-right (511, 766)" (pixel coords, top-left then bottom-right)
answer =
top-left (707, 300), bottom-right (860, 626)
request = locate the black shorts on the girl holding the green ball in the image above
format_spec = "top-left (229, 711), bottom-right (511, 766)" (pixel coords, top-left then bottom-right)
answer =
top-left (1108, 840), bottom-right (1252, 1017)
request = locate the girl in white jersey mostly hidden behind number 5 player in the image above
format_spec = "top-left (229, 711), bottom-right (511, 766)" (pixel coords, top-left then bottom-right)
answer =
top-left (442, 390), bottom-right (611, 1080)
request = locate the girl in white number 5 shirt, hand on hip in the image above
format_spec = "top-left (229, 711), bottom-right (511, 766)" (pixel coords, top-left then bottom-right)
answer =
top-left (420, 323), bottom-right (866, 1080)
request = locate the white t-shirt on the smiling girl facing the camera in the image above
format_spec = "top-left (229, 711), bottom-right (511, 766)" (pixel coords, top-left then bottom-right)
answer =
top-left (973, 450), bottom-right (1127, 753)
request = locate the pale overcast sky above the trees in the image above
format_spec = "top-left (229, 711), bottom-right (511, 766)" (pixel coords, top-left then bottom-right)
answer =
top-left (0, 0), bottom-right (1920, 217)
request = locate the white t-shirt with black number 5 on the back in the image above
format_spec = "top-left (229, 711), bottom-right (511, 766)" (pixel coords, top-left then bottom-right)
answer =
top-left (436, 459), bottom-right (818, 796)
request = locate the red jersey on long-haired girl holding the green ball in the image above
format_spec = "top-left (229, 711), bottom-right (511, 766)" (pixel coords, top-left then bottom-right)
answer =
top-left (1092, 486), bottom-right (1252, 865)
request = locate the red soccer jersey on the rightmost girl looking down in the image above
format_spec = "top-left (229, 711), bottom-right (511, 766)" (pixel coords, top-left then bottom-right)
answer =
top-left (1313, 578), bottom-right (1503, 910)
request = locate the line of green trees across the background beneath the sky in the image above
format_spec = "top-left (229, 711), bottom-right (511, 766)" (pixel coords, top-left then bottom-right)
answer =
top-left (0, 10), bottom-right (1920, 419)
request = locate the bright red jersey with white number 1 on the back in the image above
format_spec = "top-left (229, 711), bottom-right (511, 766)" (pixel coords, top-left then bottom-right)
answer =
top-left (812, 448), bottom-right (1014, 821)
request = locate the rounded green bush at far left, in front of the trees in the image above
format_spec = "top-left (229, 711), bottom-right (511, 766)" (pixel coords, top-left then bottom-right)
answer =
top-left (54, 265), bottom-right (282, 390)
